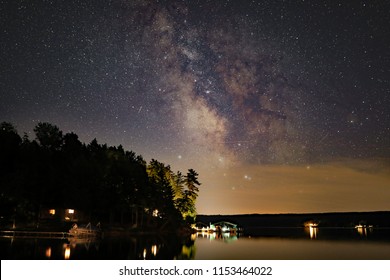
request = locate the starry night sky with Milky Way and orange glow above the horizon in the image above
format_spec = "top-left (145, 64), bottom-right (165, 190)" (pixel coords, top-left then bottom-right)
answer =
top-left (0, 0), bottom-right (390, 214)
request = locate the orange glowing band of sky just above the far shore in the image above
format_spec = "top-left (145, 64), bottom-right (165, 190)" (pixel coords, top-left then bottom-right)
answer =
top-left (197, 160), bottom-right (390, 214)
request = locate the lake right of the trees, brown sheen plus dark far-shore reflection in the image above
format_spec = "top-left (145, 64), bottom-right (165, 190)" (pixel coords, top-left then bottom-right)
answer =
top-left (195, 226), bottom-right (390, 260)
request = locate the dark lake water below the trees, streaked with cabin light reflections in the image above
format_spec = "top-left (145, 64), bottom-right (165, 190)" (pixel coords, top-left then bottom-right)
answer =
top-left (0, 235), bottom-right (195, 260)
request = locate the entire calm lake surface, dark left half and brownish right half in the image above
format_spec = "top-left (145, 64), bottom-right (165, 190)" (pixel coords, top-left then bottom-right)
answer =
top-left (0, 228), bottom-right (390, 260)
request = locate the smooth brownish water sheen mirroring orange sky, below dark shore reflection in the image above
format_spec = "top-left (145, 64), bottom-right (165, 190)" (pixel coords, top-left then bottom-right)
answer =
top-left (195, 233), bottom-right (390, 260)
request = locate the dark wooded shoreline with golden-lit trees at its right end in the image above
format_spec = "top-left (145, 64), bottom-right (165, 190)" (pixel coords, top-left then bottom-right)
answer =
top-left (0, 122), bottom-right (200, 229)
